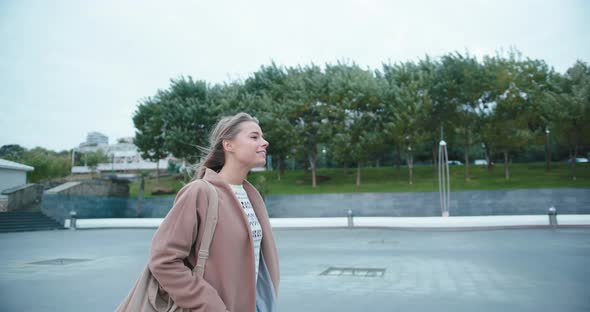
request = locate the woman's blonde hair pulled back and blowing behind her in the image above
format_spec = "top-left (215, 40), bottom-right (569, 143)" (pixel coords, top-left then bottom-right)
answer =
top-left (195, 112), bottom-right (258, 179)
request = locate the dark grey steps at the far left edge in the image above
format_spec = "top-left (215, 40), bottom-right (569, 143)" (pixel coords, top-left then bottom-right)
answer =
top-left (0, 211), bottom-right (64, 233)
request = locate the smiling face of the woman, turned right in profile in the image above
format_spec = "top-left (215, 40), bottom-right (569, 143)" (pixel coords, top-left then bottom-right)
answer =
top-left (223, 121), bottom-right (268, 169)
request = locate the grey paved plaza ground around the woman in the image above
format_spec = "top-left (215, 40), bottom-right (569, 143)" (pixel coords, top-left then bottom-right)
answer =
top-left (0, 229), bottom-right (590, 312)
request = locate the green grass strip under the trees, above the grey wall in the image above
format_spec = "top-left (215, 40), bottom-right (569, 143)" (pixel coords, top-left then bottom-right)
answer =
top-left (130, 163), bottom-right (590, 197)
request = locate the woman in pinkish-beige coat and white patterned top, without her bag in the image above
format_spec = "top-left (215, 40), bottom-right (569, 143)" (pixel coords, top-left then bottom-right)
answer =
top-left (149, 113), bottom-right (279, 312)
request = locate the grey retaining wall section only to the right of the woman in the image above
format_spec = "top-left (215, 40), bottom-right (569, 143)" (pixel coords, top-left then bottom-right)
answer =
top-left (267, 189), bottom-right (590, 217)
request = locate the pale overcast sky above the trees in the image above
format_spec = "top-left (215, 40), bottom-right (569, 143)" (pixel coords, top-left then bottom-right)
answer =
top-left (0, 0), bottom-right (590, 151)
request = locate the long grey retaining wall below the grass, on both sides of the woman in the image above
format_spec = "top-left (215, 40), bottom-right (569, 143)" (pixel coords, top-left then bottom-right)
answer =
top-left (42, 188), bottom-right (590, 222)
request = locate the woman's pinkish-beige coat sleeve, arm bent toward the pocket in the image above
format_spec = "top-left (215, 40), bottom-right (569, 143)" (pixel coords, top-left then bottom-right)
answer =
top-left (149, 183), bottom-right (226, 312)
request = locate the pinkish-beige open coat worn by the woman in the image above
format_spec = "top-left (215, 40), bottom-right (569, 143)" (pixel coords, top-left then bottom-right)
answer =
top-left (149, 169), bottom-right (279, 312)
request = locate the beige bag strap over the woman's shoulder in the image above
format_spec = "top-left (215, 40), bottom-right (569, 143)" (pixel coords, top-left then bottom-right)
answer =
top-left (193, 180), bottom-right (219, 277)
